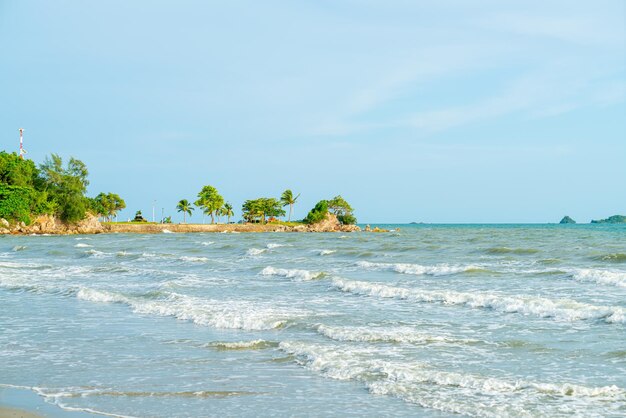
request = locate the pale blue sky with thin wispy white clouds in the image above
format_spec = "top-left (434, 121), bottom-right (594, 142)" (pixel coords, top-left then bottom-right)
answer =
top-left (0, 0), bottom-right (626, 223)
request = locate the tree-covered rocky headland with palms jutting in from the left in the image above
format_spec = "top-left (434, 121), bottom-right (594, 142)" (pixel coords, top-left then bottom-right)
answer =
top-left (0, 151), bottom-right (361, 235)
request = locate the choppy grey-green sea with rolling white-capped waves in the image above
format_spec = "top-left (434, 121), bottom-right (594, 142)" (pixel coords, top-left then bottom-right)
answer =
top-left (0, 225), bottom-right (626, 417)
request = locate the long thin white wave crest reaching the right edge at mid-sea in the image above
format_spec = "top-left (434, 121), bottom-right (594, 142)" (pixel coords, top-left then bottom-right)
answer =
top-left (332, 278), bottom-right (626, 323)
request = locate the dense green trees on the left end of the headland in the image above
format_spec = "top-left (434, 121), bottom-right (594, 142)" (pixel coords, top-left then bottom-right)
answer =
top-left (0, 151), bottom-right (126, 224)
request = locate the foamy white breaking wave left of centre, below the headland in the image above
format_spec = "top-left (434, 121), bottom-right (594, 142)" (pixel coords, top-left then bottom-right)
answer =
top-left (76, 288), bottom-right (306, 330)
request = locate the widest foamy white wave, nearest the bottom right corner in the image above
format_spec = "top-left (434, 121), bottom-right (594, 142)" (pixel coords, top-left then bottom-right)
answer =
top-left (279, 341), bottom-right (626, 417)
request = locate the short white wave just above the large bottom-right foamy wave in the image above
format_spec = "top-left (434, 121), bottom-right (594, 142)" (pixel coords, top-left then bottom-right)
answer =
top-left (316, 325), bottom-right (479, 344)
